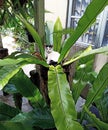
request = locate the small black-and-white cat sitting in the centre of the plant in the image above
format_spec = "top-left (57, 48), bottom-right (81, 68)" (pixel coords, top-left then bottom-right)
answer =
top-left (45, 45), bottom-right (60, 65)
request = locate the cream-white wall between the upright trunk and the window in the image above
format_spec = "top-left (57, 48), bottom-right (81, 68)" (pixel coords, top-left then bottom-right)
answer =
top-left (45, 0), bottom-right (68, 27)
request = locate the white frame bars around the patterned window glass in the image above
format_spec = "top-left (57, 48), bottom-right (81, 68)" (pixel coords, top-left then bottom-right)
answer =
top-left (66, 0), bottom-right (108, 48)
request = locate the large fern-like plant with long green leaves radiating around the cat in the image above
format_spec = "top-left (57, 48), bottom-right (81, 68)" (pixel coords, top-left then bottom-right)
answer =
top-left (0, 0), bottom-right (108, 130)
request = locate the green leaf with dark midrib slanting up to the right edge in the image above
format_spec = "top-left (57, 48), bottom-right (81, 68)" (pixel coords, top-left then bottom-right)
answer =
top-left (85, 63), bottom-right (108, 107)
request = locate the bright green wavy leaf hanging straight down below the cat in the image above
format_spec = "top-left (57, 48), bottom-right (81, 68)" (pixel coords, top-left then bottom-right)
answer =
top-left (48, 65), bottom-right (83, 130)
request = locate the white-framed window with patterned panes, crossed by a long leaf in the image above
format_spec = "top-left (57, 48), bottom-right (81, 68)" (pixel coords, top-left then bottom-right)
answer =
top-left (67, 0), bottom-right (108, 48)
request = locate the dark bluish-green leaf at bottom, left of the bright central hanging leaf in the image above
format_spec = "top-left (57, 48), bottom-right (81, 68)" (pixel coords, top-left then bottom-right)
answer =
top-left (11, 108), bottom-right (55, 129)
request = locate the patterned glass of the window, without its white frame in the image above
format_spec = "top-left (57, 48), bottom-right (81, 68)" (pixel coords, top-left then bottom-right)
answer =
top-left (70, 0), bottom-right (99, 44)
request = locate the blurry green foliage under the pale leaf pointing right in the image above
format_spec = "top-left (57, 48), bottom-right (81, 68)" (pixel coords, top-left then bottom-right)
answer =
top-left (72, 55), bottom-right (97, 102)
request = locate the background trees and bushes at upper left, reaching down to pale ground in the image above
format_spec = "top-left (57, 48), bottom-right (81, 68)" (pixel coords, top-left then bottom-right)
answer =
top-left (0, 0), bottom-right (34, 52)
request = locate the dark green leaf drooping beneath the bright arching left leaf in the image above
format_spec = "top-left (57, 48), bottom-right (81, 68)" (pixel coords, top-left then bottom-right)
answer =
top-left (10, 70), bottom-right (43, 105)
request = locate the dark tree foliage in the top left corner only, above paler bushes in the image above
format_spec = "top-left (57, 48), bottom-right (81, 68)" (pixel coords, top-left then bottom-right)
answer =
top-left (0, 0), bottom-right (34, 28)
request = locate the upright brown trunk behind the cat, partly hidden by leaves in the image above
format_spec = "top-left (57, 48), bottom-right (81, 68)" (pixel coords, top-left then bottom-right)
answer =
top-left (34, 0), bottom-right (50, 105)
